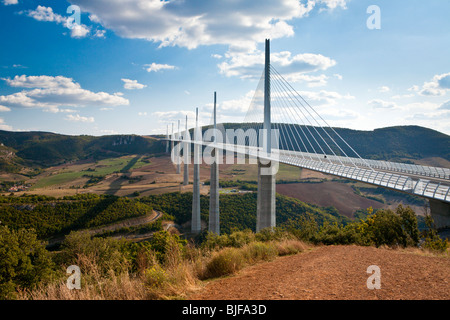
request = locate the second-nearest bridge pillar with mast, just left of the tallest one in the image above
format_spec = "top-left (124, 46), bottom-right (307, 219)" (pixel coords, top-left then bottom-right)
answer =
top-left (208, 92), bottom-right (220, 234)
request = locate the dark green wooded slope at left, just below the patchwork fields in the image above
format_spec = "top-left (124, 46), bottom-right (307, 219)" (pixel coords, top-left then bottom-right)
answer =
top-left (0, 194), bottom-right (152, 239)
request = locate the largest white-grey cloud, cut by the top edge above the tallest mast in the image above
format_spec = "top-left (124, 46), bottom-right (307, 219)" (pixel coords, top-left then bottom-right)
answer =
top-left (70, 0), bottom-right (320, 49)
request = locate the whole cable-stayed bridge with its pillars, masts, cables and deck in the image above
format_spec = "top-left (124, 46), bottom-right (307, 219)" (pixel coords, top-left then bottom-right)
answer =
top-left (166, 40), bottom-right (450, 233)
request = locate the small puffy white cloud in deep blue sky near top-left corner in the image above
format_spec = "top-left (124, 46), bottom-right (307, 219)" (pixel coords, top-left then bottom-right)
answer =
top-left (25, 5), bottom-right (91, 38)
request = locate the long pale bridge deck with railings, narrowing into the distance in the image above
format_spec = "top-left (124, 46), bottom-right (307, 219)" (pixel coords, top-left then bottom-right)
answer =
top-left (169, 138), bottom-right (450, 203)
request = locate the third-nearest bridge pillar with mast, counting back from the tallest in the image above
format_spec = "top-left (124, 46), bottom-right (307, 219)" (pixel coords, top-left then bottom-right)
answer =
top-left (191, 108), bottom-right (201, 233)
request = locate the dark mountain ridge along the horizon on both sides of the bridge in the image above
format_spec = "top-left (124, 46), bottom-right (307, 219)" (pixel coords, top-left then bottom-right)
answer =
top-left (0, 123), bottom-right (450, 172)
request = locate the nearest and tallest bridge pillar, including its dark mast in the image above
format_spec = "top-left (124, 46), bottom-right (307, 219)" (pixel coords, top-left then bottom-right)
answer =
top-left (256, 39), bottom-right (276, 232)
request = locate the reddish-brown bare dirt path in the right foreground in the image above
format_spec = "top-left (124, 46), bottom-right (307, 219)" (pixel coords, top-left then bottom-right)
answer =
top-left (190, 246), bottom-right (450, 300)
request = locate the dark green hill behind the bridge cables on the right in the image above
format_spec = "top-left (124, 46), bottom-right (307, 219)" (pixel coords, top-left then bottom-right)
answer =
top-left (203, 123), bottom-right (450, 161)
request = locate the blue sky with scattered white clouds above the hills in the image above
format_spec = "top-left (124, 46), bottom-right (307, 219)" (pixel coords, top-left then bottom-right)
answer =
top-left (0, 0), bottom-right (450, 136)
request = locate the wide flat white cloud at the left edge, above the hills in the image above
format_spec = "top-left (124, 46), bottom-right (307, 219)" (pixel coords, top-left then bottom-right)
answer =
top-left (0, 75), bottom-right (129, 112)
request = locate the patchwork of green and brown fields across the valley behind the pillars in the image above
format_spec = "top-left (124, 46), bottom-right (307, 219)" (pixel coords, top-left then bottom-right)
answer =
top-left (4, 155), bottom-right (424, 217)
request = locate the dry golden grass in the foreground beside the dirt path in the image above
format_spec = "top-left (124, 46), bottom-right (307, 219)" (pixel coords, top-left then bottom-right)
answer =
top-left (19, 232), bottom-right (310, 300)
